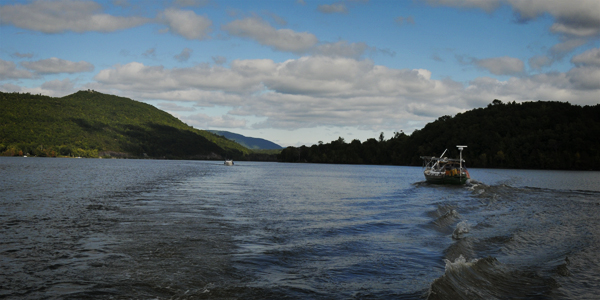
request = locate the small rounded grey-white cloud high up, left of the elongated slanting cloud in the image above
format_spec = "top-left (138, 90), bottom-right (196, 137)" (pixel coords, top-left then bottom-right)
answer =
top-left (159, 8), bottom-right (212, 40)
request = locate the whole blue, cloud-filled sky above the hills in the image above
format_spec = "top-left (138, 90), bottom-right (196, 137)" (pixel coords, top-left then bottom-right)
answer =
top-left (0, 0), bottom-right (600, 147)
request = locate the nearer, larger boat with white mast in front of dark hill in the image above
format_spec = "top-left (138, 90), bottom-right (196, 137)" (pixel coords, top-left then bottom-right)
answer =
top-left (421, 146), bottom-right (471, 184)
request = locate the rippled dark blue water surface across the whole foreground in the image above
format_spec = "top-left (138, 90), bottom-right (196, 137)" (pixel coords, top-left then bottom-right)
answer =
top-left (0, 157), bottom-right (600, 299)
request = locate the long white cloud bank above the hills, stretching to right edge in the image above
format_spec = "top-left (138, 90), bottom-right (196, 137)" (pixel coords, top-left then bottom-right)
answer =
top-left (94, 52), bottom-right (600, 130)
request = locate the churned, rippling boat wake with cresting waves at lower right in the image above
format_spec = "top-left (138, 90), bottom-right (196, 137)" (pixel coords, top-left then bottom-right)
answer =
top-left (424, 179), bottom-right (600, 299)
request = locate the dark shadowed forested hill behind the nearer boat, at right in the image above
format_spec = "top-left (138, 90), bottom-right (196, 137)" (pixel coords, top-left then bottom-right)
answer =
top-left (280, 100), bottom-right (600, 170)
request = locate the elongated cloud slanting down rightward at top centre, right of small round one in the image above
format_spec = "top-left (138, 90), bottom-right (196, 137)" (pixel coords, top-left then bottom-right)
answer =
top-left (222, 17), bottom-right (318, 53)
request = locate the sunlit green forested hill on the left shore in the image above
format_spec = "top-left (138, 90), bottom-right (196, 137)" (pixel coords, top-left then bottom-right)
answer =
top-left (0, 90), bottom-right (249, 159)
